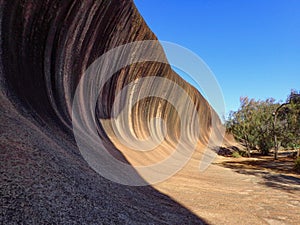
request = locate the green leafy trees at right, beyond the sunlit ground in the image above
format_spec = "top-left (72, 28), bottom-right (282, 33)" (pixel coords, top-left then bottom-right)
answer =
top-left (226, 91), bottom-right (300, 155)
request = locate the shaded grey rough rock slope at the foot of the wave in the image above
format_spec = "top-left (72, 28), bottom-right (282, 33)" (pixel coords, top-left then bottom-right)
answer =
top-left (0, 96), bottom-right (207, 224)
